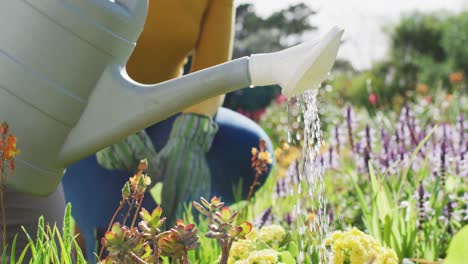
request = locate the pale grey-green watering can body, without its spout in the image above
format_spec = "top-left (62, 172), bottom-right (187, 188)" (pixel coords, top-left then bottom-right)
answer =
top-left (0, 0), bottom-right (147, 195)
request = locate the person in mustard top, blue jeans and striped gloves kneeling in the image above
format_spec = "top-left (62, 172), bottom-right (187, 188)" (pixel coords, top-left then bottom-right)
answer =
top-left (62, 0), bottom-right (272, 262)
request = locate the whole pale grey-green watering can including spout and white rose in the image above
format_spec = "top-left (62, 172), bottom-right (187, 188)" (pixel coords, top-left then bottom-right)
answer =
top-left (0, 0), bottom-right (343, 195)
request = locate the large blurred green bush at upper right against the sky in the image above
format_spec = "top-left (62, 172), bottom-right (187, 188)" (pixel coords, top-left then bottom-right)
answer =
top-left (330, 12), bottom-right (468, 109)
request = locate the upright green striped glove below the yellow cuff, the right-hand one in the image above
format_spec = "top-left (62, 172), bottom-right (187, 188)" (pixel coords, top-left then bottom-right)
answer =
top-left (158, 114), bottom-right (218, 226)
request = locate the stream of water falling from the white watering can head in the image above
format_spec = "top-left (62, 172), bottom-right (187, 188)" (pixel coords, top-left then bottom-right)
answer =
top-left (288, 88), bottom-right (330, 263)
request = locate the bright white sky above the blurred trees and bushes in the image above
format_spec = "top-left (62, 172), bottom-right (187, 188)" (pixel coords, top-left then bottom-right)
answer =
top-left (236, 0), bottom-right (468, 70)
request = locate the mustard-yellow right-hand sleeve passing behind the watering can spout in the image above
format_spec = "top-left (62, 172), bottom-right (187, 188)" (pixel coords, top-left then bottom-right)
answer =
top-left (183, 0), bottom-right (235, 116)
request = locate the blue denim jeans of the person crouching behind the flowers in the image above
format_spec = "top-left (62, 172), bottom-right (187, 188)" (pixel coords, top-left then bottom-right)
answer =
top-left (62, 108), bottom-right (273, 263)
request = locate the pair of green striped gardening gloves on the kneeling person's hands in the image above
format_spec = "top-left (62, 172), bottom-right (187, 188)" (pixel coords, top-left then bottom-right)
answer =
top-left (96, 114), bottom-right (218, 224)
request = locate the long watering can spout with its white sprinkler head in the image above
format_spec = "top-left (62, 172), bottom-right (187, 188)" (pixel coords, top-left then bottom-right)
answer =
top-left (59, 27), bottom-right (343, 165)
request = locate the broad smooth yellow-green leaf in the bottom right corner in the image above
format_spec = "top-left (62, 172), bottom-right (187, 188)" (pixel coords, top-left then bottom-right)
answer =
top-left (444, 225), bottom-right (468, 264)
